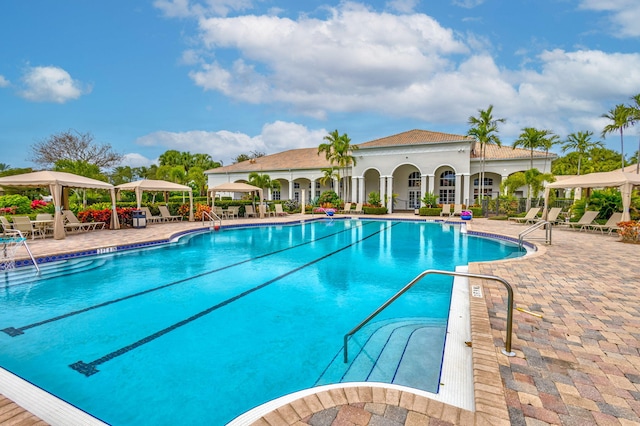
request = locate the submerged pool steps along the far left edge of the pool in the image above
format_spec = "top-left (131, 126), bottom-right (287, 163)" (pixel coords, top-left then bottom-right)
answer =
top-left (0, 259), bottom-right (106, 287)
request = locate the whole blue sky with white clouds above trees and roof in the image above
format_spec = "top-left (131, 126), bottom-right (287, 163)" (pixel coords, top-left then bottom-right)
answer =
top-left (0, 0), bottom-right (640, 167)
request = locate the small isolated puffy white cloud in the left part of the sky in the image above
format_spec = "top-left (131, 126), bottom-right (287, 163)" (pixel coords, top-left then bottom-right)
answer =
top-left (20, 66), bottom-right (91, 104)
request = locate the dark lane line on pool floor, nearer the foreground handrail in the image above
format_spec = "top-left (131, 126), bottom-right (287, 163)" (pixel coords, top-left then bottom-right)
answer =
top-left (69, 222), bottom-right (398, 377)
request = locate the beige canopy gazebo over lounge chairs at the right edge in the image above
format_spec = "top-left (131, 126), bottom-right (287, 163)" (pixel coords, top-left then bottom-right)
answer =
top-left (544, 170), bottom-right (640, 222)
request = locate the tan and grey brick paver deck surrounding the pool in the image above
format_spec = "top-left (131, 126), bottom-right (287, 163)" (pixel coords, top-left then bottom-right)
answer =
top-left (0, 214), bottom-right (640, 426)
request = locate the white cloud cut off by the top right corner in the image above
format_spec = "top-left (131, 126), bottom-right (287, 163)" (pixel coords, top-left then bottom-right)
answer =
top-left (580, 0), bottom-right (640, 38)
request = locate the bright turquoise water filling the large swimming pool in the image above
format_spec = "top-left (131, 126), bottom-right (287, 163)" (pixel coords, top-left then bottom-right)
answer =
top-left (0, 220), bottom-right (518, 425)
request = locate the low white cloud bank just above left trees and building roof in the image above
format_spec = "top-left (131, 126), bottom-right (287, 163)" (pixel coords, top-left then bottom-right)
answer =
top-left (134, 121), bottom-right (327, 165)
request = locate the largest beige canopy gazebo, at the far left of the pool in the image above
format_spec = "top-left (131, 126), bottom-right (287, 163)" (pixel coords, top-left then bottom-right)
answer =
top-left (0, 170), bottom-right (120, 240)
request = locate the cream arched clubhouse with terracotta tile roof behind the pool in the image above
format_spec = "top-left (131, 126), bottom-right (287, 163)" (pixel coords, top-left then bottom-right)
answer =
top-left (205, 130), bottom-right (556, 212)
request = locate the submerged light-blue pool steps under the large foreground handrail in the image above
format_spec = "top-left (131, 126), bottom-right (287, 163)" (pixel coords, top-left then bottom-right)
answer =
top-left (316, 319), bottom-right (446, 393)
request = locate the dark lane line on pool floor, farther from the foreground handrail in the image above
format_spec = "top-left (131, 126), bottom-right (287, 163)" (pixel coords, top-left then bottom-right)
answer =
top-left (0, 223), bottom-right (376, 337)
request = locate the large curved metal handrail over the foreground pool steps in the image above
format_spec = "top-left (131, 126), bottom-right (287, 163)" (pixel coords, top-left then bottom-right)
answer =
top-left (344, 269), bottom-right (516, 363)
